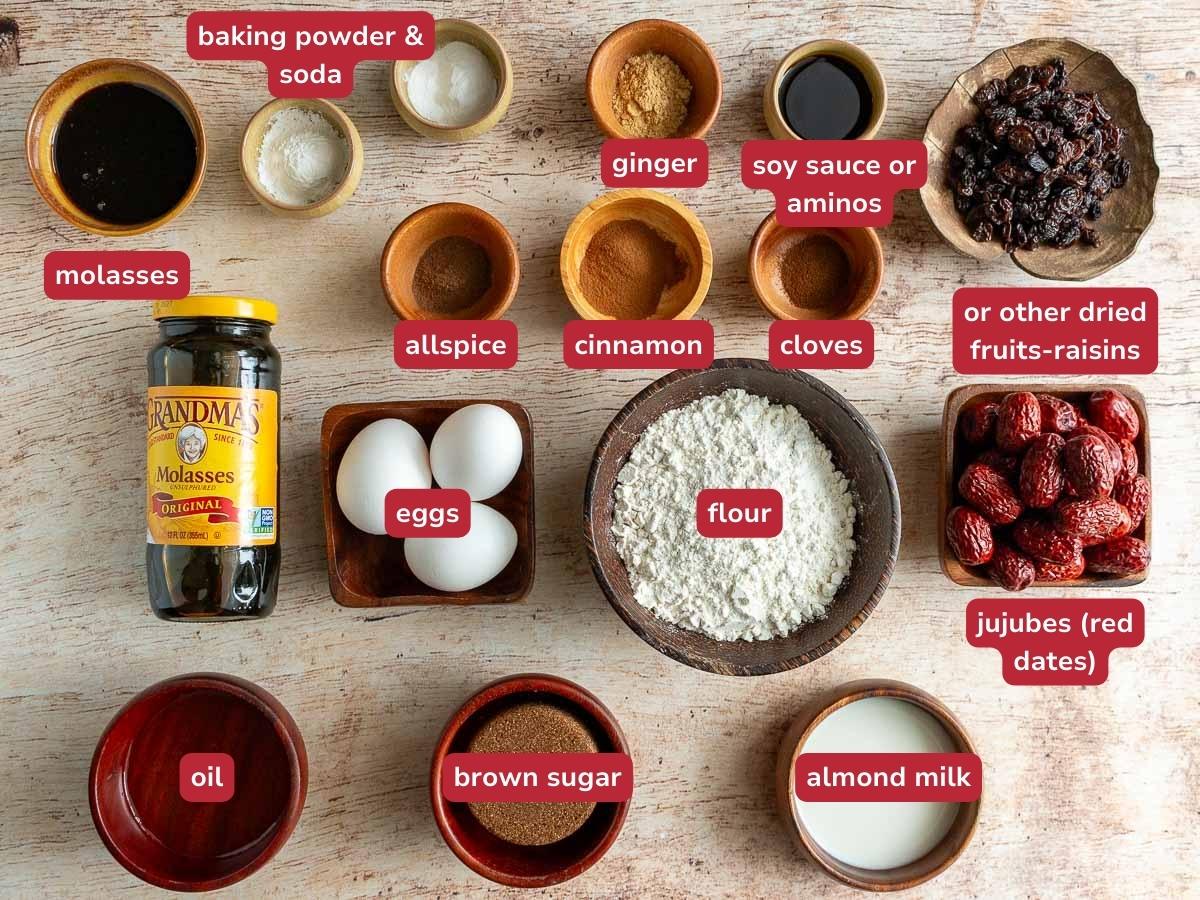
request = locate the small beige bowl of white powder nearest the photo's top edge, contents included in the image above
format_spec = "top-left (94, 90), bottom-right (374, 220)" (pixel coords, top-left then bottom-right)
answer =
top-left (389, 19), bottom-right (512, 140)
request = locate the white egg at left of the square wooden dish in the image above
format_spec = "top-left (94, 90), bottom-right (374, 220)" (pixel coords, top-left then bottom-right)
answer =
top-left (337, 419), bottom-right (433, 534)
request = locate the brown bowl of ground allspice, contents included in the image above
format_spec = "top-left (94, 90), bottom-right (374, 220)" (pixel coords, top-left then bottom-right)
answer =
top-left (379, 203), bottom-right (521, 319)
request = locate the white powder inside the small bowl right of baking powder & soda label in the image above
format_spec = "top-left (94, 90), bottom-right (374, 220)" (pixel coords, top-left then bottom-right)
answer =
top-left (404, 41), bottom-right (498, 128)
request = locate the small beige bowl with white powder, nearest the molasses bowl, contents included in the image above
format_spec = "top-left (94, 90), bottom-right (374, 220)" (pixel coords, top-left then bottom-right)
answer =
top-left (241, 100), bottom-right (362, 218)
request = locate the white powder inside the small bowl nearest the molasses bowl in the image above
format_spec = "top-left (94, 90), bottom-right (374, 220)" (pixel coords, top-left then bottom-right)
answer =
top-left (258, 107), bottom-right (350, 206)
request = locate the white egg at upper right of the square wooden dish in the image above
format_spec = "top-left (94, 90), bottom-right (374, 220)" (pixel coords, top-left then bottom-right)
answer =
top-left (430, 403), bottom-right (524, 500)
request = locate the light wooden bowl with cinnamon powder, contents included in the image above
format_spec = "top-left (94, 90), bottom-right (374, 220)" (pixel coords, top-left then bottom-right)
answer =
top-left (559, 190), bottom-right (713, 319)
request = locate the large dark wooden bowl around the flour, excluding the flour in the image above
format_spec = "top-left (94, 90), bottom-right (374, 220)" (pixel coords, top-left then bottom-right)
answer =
top-left (583, 359), bottom-right (900, 676)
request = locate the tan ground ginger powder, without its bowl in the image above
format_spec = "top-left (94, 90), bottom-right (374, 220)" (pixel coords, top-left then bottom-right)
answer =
top-left (612, 52), bottom-right (691, 138)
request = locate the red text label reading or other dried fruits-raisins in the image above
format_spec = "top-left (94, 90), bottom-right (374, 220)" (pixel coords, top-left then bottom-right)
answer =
top-left (953, 286), bottom-right (1158, 376)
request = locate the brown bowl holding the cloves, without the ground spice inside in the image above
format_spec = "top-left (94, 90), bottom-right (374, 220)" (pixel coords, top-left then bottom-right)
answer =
top-left (749, 212), bottom-right (883, 319)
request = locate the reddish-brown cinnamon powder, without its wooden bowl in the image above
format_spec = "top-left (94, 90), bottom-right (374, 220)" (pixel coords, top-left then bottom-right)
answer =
top-left (580, 218), bottom-right (688, 319)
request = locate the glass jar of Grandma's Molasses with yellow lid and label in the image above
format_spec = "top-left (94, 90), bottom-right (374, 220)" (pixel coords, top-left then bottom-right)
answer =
top-left (146, 296), bottom-right (281, 620)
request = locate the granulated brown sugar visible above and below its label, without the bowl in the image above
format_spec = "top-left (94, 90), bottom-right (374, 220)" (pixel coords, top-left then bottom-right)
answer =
top-left (468, 701), bottom-right (600, 847)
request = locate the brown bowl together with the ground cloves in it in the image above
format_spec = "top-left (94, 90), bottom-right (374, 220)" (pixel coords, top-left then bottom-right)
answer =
top-left (749, 212), bottom-right (883, 319)
